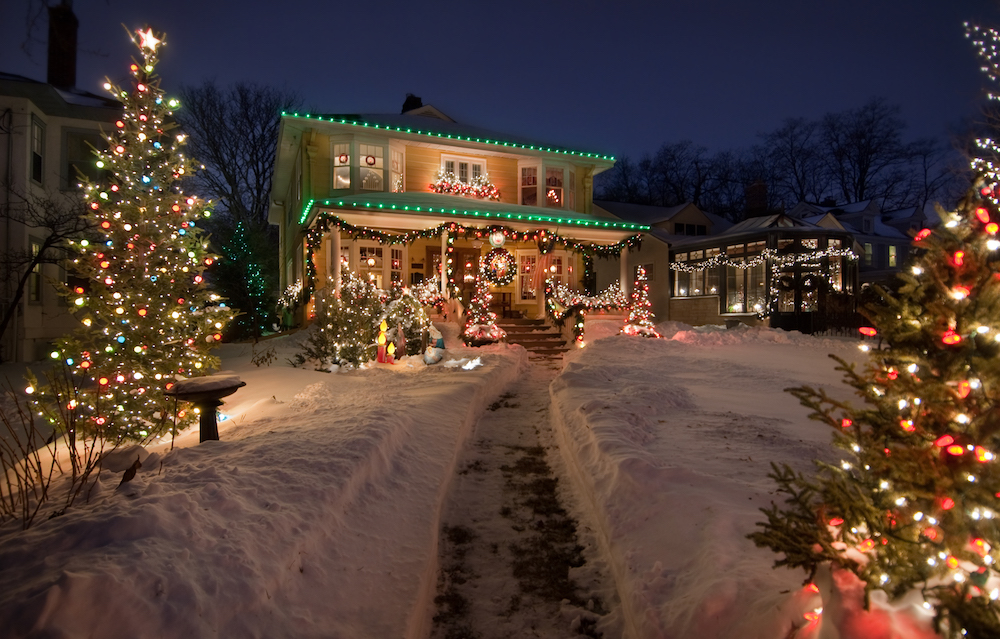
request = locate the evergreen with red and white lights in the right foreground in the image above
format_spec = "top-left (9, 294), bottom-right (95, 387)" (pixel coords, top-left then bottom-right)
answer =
top-left (750, 23), bottom-right (1000, 638)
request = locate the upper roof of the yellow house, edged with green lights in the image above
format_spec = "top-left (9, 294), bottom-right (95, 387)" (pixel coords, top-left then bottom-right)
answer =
top-left (281, 105), bottom-right (615, 161)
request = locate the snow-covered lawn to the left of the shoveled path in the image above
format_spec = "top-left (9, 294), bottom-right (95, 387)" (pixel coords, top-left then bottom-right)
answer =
top-left (0, 340), bottom-right (527, 638)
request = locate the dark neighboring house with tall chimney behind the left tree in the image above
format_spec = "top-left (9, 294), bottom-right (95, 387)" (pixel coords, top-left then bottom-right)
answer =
top-left (0, 4), bottom-right (121, 361)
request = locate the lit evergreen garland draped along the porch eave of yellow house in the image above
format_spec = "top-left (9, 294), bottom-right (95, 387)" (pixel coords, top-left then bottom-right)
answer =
top-left (304, 211), bottom-right (642, 298)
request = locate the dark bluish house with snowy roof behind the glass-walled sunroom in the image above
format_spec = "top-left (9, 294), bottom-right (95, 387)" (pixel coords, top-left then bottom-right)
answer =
top-left (788, 200), bottom-right (925, 285)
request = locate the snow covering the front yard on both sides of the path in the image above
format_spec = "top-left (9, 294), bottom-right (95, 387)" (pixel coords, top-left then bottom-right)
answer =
top-left (0, 322), bottom-right (925, 639)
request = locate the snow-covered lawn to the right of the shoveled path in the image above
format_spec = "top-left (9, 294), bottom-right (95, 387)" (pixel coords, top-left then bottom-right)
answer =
top-left (550, 324), bottom-right (920, 639)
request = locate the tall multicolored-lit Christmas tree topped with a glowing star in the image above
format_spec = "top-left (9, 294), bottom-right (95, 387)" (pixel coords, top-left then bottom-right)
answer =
top-left (27, 29), bottom-right (233, 440)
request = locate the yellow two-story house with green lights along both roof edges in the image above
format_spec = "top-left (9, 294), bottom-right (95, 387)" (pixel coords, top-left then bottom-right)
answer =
top-left (268, 96), bottom-right (646, 320)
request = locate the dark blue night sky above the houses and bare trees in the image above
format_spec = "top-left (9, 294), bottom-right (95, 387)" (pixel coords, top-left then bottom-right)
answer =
top-left (0, 0), bottom-right (1000, 156)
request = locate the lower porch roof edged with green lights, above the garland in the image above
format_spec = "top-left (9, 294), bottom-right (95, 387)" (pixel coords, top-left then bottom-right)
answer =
top-left (299, 192), bottom-right (649, 238)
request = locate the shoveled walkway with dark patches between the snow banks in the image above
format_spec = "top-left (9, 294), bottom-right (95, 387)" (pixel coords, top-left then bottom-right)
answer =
top-left (431, 359), bottom-right (621, 639)
